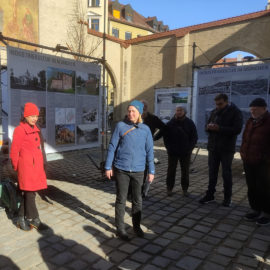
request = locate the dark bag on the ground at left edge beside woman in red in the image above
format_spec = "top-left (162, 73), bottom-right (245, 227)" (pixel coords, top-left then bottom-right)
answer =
top-left (0, 179), bottom-right (22, 217)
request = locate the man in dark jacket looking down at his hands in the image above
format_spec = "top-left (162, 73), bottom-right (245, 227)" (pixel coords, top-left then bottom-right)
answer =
top-left (200, 94), bottom-right (243, 207)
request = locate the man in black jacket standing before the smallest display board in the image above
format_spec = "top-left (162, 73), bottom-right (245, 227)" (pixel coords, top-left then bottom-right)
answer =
top-left (163, 106), bottom-right (198, 196)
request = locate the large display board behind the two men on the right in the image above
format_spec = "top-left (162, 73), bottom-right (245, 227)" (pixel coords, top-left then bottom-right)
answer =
top-left (192, 64), bottom-right (270, 145)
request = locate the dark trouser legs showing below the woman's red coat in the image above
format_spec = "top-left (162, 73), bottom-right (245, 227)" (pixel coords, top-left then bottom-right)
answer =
top-left (18, 191), bottom-right (38, 219)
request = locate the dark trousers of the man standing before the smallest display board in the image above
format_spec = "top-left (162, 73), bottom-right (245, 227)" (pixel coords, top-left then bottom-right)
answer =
top-left (166, 153), bottom-right (191, 190)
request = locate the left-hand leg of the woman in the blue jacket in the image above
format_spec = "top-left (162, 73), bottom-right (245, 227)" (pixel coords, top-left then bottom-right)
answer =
top-left (114, 169), bottom-right (130, 233)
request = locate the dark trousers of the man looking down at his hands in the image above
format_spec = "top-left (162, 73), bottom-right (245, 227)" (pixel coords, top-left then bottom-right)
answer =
top-left (207, 151), bottom-right (234, 200)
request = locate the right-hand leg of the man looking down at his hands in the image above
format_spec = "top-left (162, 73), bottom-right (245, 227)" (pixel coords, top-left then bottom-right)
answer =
top-left (221, 153), bottom-right (234, 206)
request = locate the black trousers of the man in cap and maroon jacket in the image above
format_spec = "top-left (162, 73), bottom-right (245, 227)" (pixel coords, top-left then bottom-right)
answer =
top-left (244, 161), bottom-right (270, 214)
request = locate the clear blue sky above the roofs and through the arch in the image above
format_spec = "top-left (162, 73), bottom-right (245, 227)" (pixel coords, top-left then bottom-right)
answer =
top-left (119, 0), bottom-right (267, 57)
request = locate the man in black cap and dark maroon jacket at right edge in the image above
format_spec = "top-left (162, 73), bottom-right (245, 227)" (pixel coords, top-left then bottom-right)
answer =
top-left (240, 98), bottom-right (270, 226)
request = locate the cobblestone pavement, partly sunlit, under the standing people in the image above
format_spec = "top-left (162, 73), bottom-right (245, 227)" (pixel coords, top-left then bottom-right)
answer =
top-left (0, 147), bottom-right (270, 270)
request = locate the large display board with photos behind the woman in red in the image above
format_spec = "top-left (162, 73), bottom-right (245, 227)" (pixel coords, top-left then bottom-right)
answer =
top-left (6, 46), bottom-right (101, 153)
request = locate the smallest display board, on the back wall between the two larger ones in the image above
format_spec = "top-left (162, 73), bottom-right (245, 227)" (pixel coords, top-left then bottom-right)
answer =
top-left (155, 87), bottom-right (191, 123)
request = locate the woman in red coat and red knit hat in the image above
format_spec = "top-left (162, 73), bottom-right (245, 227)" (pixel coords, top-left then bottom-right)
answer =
top-left (10, 103), bottom-right (47, 231)
